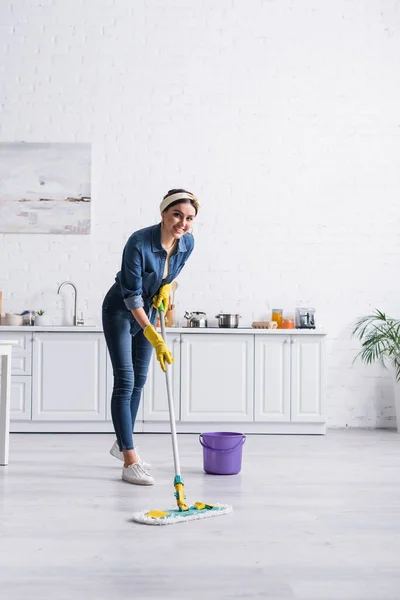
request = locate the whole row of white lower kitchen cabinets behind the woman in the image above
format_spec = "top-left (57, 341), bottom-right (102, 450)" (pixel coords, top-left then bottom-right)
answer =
top-left (0, 327), bottom-right (326, 434)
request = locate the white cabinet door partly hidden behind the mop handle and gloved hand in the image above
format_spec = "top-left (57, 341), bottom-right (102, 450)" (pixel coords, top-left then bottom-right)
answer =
top-left (142, 333), bottom-right (181, 421)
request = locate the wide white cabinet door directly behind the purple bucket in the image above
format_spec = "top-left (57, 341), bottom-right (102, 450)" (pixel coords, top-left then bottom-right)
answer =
top-left (181, 333), bottom-right (254, 422)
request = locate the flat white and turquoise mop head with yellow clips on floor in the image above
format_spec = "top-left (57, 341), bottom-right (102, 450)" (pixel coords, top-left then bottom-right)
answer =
top-left (132, 502), bottom-right (232, 525)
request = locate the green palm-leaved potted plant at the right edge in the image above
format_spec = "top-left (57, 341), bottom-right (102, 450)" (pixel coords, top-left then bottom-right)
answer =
top-left (352, 310), bottom-right (400, 433)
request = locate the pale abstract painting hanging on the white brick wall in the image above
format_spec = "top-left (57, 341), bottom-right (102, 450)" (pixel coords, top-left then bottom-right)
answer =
top-left (0, 142), bottom-right (91, 235)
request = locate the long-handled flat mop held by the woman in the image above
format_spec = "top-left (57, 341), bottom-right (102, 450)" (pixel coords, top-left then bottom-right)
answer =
top-left (132, 306), bottom-right (232, 525)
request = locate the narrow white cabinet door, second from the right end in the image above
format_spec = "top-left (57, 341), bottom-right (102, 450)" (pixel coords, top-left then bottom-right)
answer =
top-left (254, 334), bottom-right (290, 422)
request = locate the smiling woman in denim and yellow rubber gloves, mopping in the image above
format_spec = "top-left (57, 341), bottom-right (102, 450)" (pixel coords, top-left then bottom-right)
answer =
top-left (102, 189), bottom-right (199, 485)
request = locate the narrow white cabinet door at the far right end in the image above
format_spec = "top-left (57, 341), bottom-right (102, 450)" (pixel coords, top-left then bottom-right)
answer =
top-left (291, 335), bottom-right (324, 422)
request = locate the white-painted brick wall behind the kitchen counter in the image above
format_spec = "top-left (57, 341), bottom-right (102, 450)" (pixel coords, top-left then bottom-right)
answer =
top-left (0, 0), bottom-right (400, 427)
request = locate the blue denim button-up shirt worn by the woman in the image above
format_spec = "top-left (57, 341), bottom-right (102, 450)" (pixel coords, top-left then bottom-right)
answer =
top-left (115, 223), bottom-right (194, 333)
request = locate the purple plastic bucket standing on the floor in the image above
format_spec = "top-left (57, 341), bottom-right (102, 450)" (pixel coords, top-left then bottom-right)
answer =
top-left (199, 431), bottom-right (246, 475)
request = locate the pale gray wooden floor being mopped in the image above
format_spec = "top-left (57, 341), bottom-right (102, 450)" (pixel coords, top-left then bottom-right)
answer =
top-left (0, 431), bottom-right (400, 600)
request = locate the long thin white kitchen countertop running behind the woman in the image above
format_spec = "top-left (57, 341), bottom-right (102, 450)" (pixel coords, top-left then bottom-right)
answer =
top-left (0, 325), bottom-right (326, 335)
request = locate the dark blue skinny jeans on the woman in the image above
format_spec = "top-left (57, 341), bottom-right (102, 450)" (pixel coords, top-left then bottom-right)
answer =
top-left (102, 284), bottom-right (153, 450)
